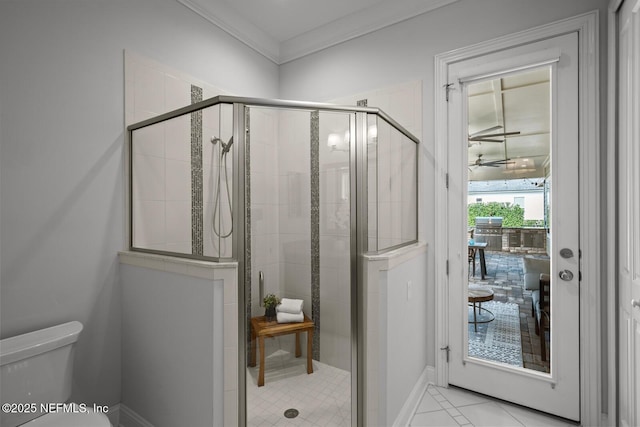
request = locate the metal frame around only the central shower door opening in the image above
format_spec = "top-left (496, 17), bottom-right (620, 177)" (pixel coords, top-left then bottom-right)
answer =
top-left (232, 99), bottom-right (364, 426)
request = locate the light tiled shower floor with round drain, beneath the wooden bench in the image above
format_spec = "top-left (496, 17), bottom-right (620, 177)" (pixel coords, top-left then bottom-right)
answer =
top-left (247, 355), bottom-right (351, 427)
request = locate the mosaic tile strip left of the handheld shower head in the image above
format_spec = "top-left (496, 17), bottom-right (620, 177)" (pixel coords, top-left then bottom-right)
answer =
top-left (191, 85), bottom-right (204, 255)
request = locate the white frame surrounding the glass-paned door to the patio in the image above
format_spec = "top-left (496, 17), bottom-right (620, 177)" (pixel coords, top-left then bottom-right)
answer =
top-left (434, 11), bottom-right (602, 425)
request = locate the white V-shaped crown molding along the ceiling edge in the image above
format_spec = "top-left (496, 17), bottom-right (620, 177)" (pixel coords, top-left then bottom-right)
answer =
top-left (177, 0), bottom-right (458, 65)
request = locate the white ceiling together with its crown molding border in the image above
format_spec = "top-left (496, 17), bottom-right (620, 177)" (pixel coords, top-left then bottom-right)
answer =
top-left (177, 0), bottom-right (457, 64)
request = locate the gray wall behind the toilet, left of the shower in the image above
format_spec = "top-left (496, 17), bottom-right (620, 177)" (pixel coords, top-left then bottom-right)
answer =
top-left (0, 0), bottom-right (278, 405)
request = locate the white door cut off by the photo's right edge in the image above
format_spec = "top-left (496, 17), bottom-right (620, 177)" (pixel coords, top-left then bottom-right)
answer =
top-left (617, 0), bottom-right (640, 426)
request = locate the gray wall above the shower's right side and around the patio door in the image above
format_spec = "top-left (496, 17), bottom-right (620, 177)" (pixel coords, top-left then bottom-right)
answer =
top-left (280, 0), bottom-right (608, 374)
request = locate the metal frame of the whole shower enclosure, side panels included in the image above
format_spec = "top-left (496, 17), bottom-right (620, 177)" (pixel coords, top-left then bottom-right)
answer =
top-left (127, 95), bottom-right (420, 426)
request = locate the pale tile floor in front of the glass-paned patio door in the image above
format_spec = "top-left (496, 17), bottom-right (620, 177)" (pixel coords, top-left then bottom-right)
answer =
top-left (409, 384), bottom-right (576, 427)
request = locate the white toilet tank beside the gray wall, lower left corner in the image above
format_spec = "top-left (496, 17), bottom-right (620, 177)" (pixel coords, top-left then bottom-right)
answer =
top-left (0, 321), bottom-right (82, 426)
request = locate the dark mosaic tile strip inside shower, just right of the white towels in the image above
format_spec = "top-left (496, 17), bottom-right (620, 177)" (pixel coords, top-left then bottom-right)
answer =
top-left (310, 111), bottom-right (320, 360)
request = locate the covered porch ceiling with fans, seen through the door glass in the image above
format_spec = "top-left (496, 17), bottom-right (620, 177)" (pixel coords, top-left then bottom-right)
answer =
top-left (468, 67), bottom-right (551, 181)
